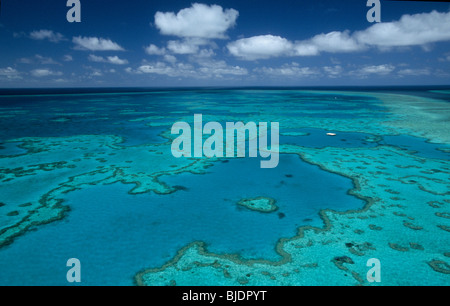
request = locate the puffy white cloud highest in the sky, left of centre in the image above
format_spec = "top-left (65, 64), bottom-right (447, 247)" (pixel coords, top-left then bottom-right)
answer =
top-left (155, 3), bottom-right (239, 39)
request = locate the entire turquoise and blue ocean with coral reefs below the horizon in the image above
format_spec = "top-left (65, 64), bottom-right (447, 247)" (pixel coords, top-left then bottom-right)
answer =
top-left (0, 87), bottom-right (450, 286)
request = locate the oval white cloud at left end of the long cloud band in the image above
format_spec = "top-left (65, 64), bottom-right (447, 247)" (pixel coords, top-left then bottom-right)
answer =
top-left (227, 35), bottom-right (293, 60)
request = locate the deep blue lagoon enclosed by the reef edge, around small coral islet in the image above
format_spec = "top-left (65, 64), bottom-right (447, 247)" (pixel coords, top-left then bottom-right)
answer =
top-left (0, 155), bottom-right (364, 285)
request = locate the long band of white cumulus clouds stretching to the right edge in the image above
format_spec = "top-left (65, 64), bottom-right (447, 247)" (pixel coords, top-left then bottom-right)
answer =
top-left (227, 11), bottom-right (450, 60)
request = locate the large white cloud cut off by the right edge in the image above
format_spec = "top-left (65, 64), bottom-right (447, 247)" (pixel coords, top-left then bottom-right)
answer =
top-left (354, 11), bottom-right (450, 47)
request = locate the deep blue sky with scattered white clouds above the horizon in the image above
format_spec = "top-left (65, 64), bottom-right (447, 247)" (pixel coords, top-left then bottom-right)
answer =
top-left (0, 0), bottom-right (450, 88)
